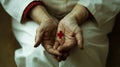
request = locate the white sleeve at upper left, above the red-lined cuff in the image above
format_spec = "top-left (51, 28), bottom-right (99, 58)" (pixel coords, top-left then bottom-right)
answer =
top-left (0, 0), bottom-right (33, 22)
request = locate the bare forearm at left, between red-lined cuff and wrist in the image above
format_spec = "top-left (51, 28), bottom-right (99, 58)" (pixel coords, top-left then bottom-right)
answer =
top-left (29, 5), bottom-right (50, 24)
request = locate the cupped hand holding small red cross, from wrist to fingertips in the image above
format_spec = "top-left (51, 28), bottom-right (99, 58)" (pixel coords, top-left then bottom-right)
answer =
top-left (54, 16), bottom-right (83, 60)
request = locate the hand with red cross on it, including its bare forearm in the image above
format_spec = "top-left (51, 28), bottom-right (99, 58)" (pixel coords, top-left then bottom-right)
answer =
top-left (54, 5), bottom-right (88, 61)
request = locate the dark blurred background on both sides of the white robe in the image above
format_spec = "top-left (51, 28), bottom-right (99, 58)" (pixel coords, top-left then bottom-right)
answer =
top-left (0, 5), bottom-right (120, 67)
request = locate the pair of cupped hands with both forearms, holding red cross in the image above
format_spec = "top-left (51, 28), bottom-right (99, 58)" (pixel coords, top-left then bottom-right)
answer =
top-left (29, 4), bottom-right (88, 61)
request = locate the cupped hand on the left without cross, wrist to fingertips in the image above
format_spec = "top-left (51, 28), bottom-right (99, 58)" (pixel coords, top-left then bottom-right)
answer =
top-left (34, 19), bottom-right (60, 55)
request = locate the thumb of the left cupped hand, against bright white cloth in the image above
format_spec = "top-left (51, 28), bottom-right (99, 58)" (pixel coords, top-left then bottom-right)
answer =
top-left (34, 28), bottom-right (44, 47)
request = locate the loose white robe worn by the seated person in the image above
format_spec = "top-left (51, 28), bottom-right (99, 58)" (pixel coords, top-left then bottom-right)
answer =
top-left (0, 0), bottom-right (120, 67)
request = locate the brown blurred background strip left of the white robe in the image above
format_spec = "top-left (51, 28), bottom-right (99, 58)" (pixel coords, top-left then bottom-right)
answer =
top-left (0, 4), bottom-right (19, 67)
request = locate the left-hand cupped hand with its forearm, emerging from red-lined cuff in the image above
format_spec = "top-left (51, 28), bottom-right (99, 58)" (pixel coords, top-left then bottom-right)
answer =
top-left (30, 5), bottom-right (61, 55)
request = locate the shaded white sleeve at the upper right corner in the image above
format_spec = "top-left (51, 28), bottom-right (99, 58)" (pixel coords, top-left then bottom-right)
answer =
top-left (78, 0), bottom-right (120, 24)
